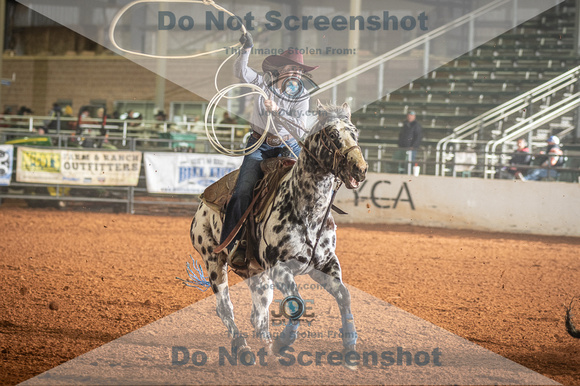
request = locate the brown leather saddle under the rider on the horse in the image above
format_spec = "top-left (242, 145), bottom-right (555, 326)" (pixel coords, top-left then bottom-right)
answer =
top-left (200, 157), bottom-right (296, 268)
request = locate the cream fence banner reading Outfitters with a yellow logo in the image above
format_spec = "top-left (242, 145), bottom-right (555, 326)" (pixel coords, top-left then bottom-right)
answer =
top-left (16, 147), bottom-right (141, 186)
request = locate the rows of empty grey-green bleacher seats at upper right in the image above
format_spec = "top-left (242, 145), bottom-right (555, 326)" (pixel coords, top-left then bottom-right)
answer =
top-left (353, 0), bottom-right (580, 151)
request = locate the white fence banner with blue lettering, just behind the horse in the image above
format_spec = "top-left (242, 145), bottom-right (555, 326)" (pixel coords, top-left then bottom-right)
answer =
top-left (145, 153), bottom-right (242, 194)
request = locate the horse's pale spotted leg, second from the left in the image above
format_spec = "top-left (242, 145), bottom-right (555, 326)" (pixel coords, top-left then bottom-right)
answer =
top-left (247, 272), bottom-right (274, 343)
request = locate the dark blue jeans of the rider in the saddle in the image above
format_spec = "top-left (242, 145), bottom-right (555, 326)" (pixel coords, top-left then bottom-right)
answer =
top-left (220, 136), bottom-right (300, 250)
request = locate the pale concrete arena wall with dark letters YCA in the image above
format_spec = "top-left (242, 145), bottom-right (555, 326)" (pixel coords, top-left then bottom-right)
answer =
top-left (334, 173), bottom-right (580, 236)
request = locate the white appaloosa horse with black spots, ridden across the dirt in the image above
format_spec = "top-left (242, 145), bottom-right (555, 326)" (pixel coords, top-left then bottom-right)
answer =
top-left (191, 102), bottom-right (368, 353)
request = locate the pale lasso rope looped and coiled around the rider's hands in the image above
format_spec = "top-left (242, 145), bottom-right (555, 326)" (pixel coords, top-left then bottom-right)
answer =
top-left (109, 0), bottom-right (298, 158)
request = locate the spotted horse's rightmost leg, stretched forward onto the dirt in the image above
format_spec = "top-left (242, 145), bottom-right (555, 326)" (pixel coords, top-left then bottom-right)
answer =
top-left (310, 255), bottom-right (357, 352)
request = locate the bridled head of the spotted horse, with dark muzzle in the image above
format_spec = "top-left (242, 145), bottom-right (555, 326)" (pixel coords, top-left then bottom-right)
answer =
top-left (307, 101), bottom-right (368, 189)
